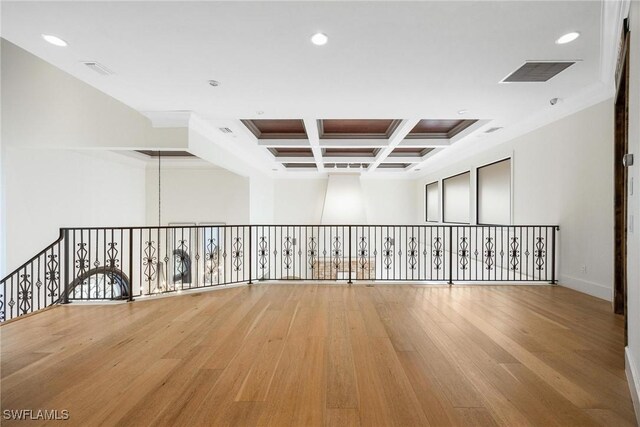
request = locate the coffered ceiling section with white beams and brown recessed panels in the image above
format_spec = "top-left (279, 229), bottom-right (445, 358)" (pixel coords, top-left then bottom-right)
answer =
top-left (242, 119), bottom-right (478, 172)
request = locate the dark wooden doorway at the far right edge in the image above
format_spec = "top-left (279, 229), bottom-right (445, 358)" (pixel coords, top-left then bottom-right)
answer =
top-left (613, 20), bottom-right (629, 344)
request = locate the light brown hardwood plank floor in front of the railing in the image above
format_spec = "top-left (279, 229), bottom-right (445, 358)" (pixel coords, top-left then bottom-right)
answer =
top-left (0, 284), bottom-right (636, 426)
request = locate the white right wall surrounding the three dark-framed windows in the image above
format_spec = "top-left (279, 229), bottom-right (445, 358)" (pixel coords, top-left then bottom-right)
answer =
top-left (416, 100), bottom-right (613, 300)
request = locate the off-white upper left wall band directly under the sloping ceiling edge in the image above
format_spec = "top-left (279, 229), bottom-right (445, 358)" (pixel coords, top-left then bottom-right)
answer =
top-left (1, 39), bottom-right (187, 149)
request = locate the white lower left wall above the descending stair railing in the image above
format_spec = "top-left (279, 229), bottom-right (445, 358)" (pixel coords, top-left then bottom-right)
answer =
top-left (0, 147), bottom-right (145, 277)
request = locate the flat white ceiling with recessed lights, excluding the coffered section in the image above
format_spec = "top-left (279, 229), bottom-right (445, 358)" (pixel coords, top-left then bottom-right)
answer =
top-left (1, 1), bottom-right (606, 176)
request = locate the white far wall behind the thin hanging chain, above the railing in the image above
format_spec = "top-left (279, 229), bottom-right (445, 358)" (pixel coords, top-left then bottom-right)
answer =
top-left (146, 160), bottom-right (250, 225)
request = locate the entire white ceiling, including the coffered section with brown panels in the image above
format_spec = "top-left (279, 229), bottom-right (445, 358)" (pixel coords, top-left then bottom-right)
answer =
top-left (1, 0), bottom-right (619, 176)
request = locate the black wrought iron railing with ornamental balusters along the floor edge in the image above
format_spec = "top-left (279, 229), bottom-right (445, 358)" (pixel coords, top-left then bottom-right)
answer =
top-left (0, 224), bottom-right (559, 321)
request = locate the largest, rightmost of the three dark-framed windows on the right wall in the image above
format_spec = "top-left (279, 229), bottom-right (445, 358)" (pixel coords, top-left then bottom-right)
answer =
top-left (478, 159), bottom-right (511, 224)
